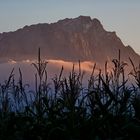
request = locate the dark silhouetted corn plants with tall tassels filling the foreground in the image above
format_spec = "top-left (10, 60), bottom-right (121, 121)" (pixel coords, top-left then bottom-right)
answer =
top-left (0, 50), bottom-right (140, 140)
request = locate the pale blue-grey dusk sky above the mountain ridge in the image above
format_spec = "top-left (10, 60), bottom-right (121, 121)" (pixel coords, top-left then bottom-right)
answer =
top-left (0, 0), bottom-right (140, 54)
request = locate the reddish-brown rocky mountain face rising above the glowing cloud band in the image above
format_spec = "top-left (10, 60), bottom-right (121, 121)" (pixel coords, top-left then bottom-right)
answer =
top-left (0, 16), bottom-right (140, 63)
